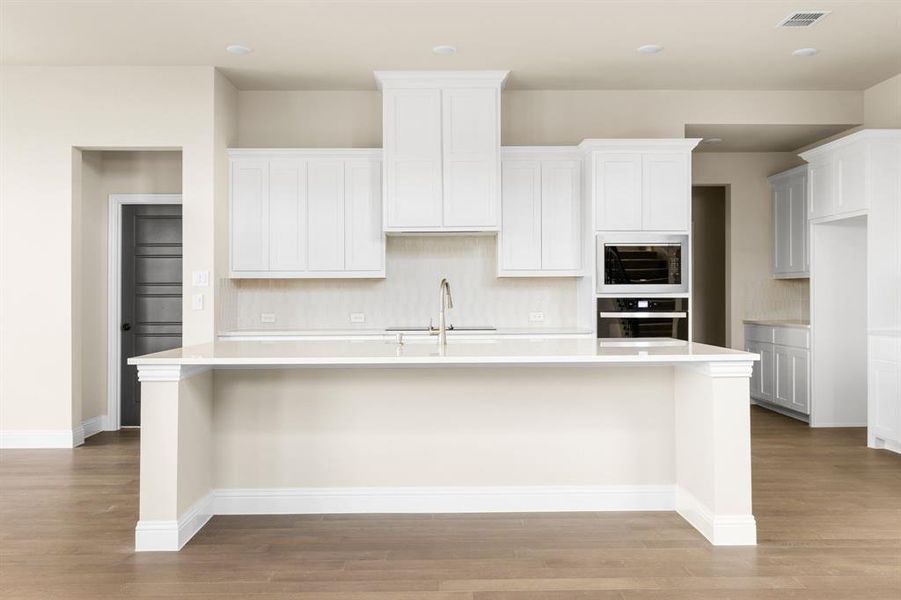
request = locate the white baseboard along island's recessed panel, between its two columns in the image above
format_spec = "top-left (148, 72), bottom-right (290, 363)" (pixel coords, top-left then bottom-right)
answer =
top-left (213, 485), bottom-right (675, 515)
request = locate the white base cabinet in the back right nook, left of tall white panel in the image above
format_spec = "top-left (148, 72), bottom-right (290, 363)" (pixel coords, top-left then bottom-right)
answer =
top-left (745, 323), bottom-right (810, 415)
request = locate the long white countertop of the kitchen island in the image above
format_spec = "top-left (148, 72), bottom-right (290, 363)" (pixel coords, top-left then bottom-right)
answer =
top-left (128, 338), bottom-right (759, 367)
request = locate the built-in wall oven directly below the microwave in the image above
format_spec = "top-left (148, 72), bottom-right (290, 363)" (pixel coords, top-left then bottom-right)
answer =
top-left (597, 298), bottom-right (688, 341)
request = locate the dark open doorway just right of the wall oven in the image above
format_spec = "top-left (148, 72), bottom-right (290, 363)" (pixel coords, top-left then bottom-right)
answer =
top-left (690, 185), bottom-right (728, 346)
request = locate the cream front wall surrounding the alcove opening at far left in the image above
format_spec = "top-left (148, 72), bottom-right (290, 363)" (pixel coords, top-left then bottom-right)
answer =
top-left (0, 67), bottom-right (215, 432)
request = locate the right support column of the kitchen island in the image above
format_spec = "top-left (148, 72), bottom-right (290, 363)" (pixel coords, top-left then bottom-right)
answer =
top-left (674, 361), bottom-right (757, 546)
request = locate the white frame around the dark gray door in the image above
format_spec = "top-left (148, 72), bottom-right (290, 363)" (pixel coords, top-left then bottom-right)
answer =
top-left (104, 194), bottom-right (182, 431)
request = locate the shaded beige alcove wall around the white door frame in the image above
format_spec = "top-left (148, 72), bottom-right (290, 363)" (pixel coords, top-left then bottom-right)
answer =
top-left (79, 151), bottom-right (182, 420)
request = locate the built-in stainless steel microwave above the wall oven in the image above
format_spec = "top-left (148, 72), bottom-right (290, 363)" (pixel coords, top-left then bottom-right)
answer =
top-left (596, 233), bottom-right (690, 294)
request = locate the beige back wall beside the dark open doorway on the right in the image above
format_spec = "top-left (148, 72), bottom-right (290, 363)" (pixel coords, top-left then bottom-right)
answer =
top-left (692, 152), bottom-right (810, 348)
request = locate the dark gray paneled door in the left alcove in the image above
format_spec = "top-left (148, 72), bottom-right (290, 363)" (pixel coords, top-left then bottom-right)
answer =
top-left (119, 204), bottom-right (181, 426)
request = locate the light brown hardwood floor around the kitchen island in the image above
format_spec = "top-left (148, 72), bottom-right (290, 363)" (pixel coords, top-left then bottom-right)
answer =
top-left (0, 408), bottom-right (901, 600)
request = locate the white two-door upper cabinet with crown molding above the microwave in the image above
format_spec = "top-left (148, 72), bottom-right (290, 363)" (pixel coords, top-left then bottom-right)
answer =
top-left (579, 139), bottom-right (699, 232)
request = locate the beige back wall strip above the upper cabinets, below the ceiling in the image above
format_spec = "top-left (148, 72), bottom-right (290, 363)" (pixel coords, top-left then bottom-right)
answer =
top-left (238, 90), bottom-right (863, 148)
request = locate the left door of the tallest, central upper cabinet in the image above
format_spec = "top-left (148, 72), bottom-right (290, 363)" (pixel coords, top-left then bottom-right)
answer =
top-left (382, 89), bottom-right (442, 228)
